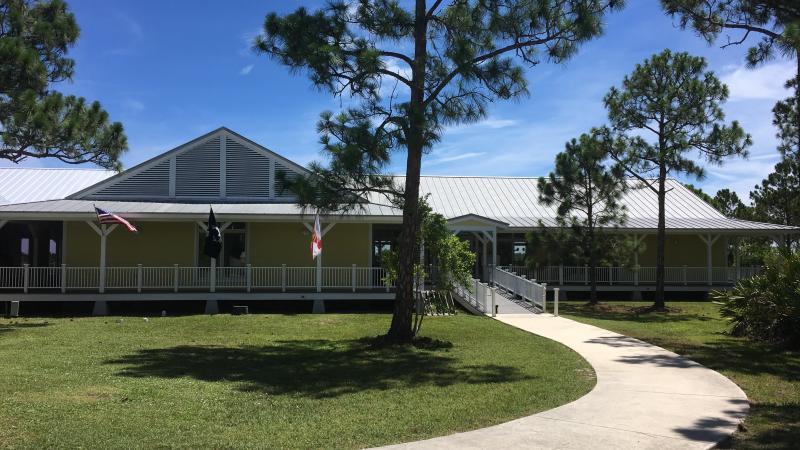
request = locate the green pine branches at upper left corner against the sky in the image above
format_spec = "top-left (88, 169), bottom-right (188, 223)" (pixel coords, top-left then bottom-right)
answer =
top-left (0, 0), bottom-right (128, 169)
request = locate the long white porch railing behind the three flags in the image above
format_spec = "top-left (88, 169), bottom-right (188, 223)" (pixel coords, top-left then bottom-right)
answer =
top-left (0, 265), bottom-right (394, 293)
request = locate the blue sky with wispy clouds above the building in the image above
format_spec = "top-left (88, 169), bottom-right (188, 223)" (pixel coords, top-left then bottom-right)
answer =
top-left (9, 0), bottom-right (794, 198)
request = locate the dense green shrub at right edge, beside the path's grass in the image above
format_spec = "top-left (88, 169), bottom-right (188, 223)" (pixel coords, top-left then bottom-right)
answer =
top-left (712, 252), bottom-right (800, 347)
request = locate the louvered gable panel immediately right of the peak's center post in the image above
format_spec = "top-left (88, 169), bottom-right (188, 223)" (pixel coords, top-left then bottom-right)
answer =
top-left (225, 139), bottom-right (270, 199)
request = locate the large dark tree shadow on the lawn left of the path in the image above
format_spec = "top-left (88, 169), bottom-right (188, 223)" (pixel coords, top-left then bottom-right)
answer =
top-left (106, 339), bottom-right (533, 398)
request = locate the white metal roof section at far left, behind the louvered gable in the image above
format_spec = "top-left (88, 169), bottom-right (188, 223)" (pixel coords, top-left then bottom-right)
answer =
top-left (0, 167), bottom-right (116, 205)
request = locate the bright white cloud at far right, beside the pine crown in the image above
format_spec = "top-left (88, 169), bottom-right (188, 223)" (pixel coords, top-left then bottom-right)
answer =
top-left (721, 62), bottom-right (796, 101)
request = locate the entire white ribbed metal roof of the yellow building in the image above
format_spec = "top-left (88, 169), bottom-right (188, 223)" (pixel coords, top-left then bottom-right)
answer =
top-left (0, 128), bottom-right (800, 233)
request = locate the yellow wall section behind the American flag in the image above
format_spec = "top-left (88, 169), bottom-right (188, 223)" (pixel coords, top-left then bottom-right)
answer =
top-left (64, 222), bottom-right (197, 266)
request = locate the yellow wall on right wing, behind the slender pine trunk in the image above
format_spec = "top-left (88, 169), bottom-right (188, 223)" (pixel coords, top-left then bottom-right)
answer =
top-left (639, 234), bottom-right (727, 267)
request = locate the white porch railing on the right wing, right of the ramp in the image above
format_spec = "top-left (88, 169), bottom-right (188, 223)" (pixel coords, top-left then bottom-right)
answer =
top-left (500, 266), bottom-right (761, 286)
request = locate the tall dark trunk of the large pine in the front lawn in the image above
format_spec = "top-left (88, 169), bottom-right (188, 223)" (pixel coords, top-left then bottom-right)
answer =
top-left (388, 0), bottom-right (427, 343)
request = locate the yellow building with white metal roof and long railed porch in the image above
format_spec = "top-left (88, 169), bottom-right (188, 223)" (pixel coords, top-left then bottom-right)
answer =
top-left (0, 128), bottom-right (797, 310)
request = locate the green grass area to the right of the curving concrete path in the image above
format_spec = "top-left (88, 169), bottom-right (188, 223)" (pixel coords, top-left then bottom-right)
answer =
top-left (561, 302), bottom-right (800, 449)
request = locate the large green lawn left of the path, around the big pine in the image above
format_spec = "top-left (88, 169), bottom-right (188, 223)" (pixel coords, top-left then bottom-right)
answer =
top-left (0, 314), bottom-right (595, 448)
